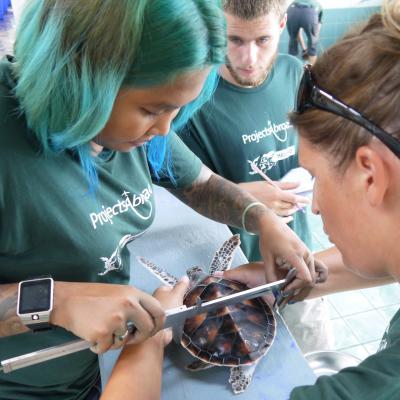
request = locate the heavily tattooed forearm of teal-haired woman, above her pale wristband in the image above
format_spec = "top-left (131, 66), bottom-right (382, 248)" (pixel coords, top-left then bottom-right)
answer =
top-left (171, 168), bottom-right (268, 232)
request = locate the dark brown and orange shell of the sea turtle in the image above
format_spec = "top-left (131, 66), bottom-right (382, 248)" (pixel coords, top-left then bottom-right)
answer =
top-left (181, 276), bottom-right (276, 367)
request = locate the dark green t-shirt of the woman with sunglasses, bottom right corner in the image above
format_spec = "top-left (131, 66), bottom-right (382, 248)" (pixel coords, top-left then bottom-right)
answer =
top-left (290, 304), bottom-right (400, 400)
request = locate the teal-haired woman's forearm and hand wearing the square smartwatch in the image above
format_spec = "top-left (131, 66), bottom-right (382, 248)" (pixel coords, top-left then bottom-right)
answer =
top-left (0, 281), bottom-right (164, 353)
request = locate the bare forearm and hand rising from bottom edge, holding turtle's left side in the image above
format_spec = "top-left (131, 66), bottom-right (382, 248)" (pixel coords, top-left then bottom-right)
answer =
top-left (101, 277), bottom-right (189, 400)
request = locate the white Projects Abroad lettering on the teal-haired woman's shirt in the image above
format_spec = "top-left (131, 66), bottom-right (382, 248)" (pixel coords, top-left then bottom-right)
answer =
top-left (89, 185), bottom-right (153, 229)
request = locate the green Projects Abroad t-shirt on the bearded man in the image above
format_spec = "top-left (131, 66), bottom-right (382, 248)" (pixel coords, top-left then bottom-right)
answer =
top-left (180, 55), bottom-right (311, 261)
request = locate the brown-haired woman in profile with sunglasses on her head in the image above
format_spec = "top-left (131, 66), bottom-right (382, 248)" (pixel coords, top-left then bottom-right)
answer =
top-left (101, 0), bottom-right (400, 400)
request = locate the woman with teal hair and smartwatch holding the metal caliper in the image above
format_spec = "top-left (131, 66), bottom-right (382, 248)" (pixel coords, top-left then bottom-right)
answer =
top-left (0, 0), bottom-right (315, 400)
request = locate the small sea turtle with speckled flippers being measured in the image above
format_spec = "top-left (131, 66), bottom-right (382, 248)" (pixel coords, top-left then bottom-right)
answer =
top-left (138, 235), bottom-right (276, 394)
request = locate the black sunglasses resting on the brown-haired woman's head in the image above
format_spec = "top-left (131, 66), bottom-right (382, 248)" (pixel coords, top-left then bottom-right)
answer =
top-left (295, 65), bottom-right (400, 158)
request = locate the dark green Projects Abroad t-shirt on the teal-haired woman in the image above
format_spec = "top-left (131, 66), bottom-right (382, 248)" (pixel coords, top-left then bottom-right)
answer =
top-left (0, 54), bottom-right (201, 400)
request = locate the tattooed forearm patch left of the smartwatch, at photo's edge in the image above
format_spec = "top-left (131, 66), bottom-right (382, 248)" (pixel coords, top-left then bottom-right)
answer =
top-left (0, 284), bottom-right (28, 337)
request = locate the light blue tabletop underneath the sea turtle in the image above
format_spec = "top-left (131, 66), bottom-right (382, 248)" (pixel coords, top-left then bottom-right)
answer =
top-left (100, 188), bottom-right (316, 400)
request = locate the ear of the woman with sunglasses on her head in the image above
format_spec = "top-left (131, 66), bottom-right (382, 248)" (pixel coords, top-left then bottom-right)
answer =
top-left (355, 146), bottom-right (390, 207)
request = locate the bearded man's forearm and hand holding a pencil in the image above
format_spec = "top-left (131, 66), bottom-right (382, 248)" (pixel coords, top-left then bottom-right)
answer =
top-left (238, 181), bottom-right (310, 217)
